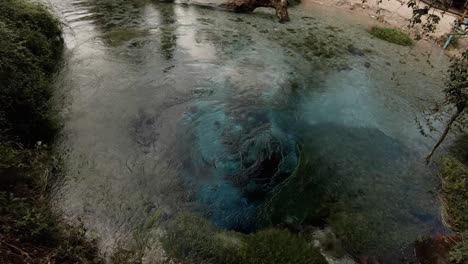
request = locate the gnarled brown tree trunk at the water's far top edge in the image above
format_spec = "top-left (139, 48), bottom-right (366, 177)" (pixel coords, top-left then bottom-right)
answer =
top-left (220, 0), bottom-right (289, 23)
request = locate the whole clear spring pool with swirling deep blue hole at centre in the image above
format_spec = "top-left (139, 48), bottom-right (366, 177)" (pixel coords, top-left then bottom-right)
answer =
top-left (48, 0), bottom-right (445, 260)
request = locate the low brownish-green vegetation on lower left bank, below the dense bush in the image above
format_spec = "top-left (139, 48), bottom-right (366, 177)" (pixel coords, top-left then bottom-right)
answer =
top-left (0, 143), bottom-right (100, 263)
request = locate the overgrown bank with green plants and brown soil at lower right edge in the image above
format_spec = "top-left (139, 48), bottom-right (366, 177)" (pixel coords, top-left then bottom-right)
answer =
top-left (415, 134), bottom-right (468, 264)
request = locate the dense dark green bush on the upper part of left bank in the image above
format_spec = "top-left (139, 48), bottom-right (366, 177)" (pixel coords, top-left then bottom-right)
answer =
top-left (0, 0), bottom-right (63, 144)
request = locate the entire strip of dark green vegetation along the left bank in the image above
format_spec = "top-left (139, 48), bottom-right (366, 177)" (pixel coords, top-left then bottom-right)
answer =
top-left (0, 0), bottom-right (101, 263)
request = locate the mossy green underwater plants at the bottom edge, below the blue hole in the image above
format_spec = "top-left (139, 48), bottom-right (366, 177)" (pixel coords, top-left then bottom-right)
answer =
top-left (161, 214), bottom-right (326, 264)
